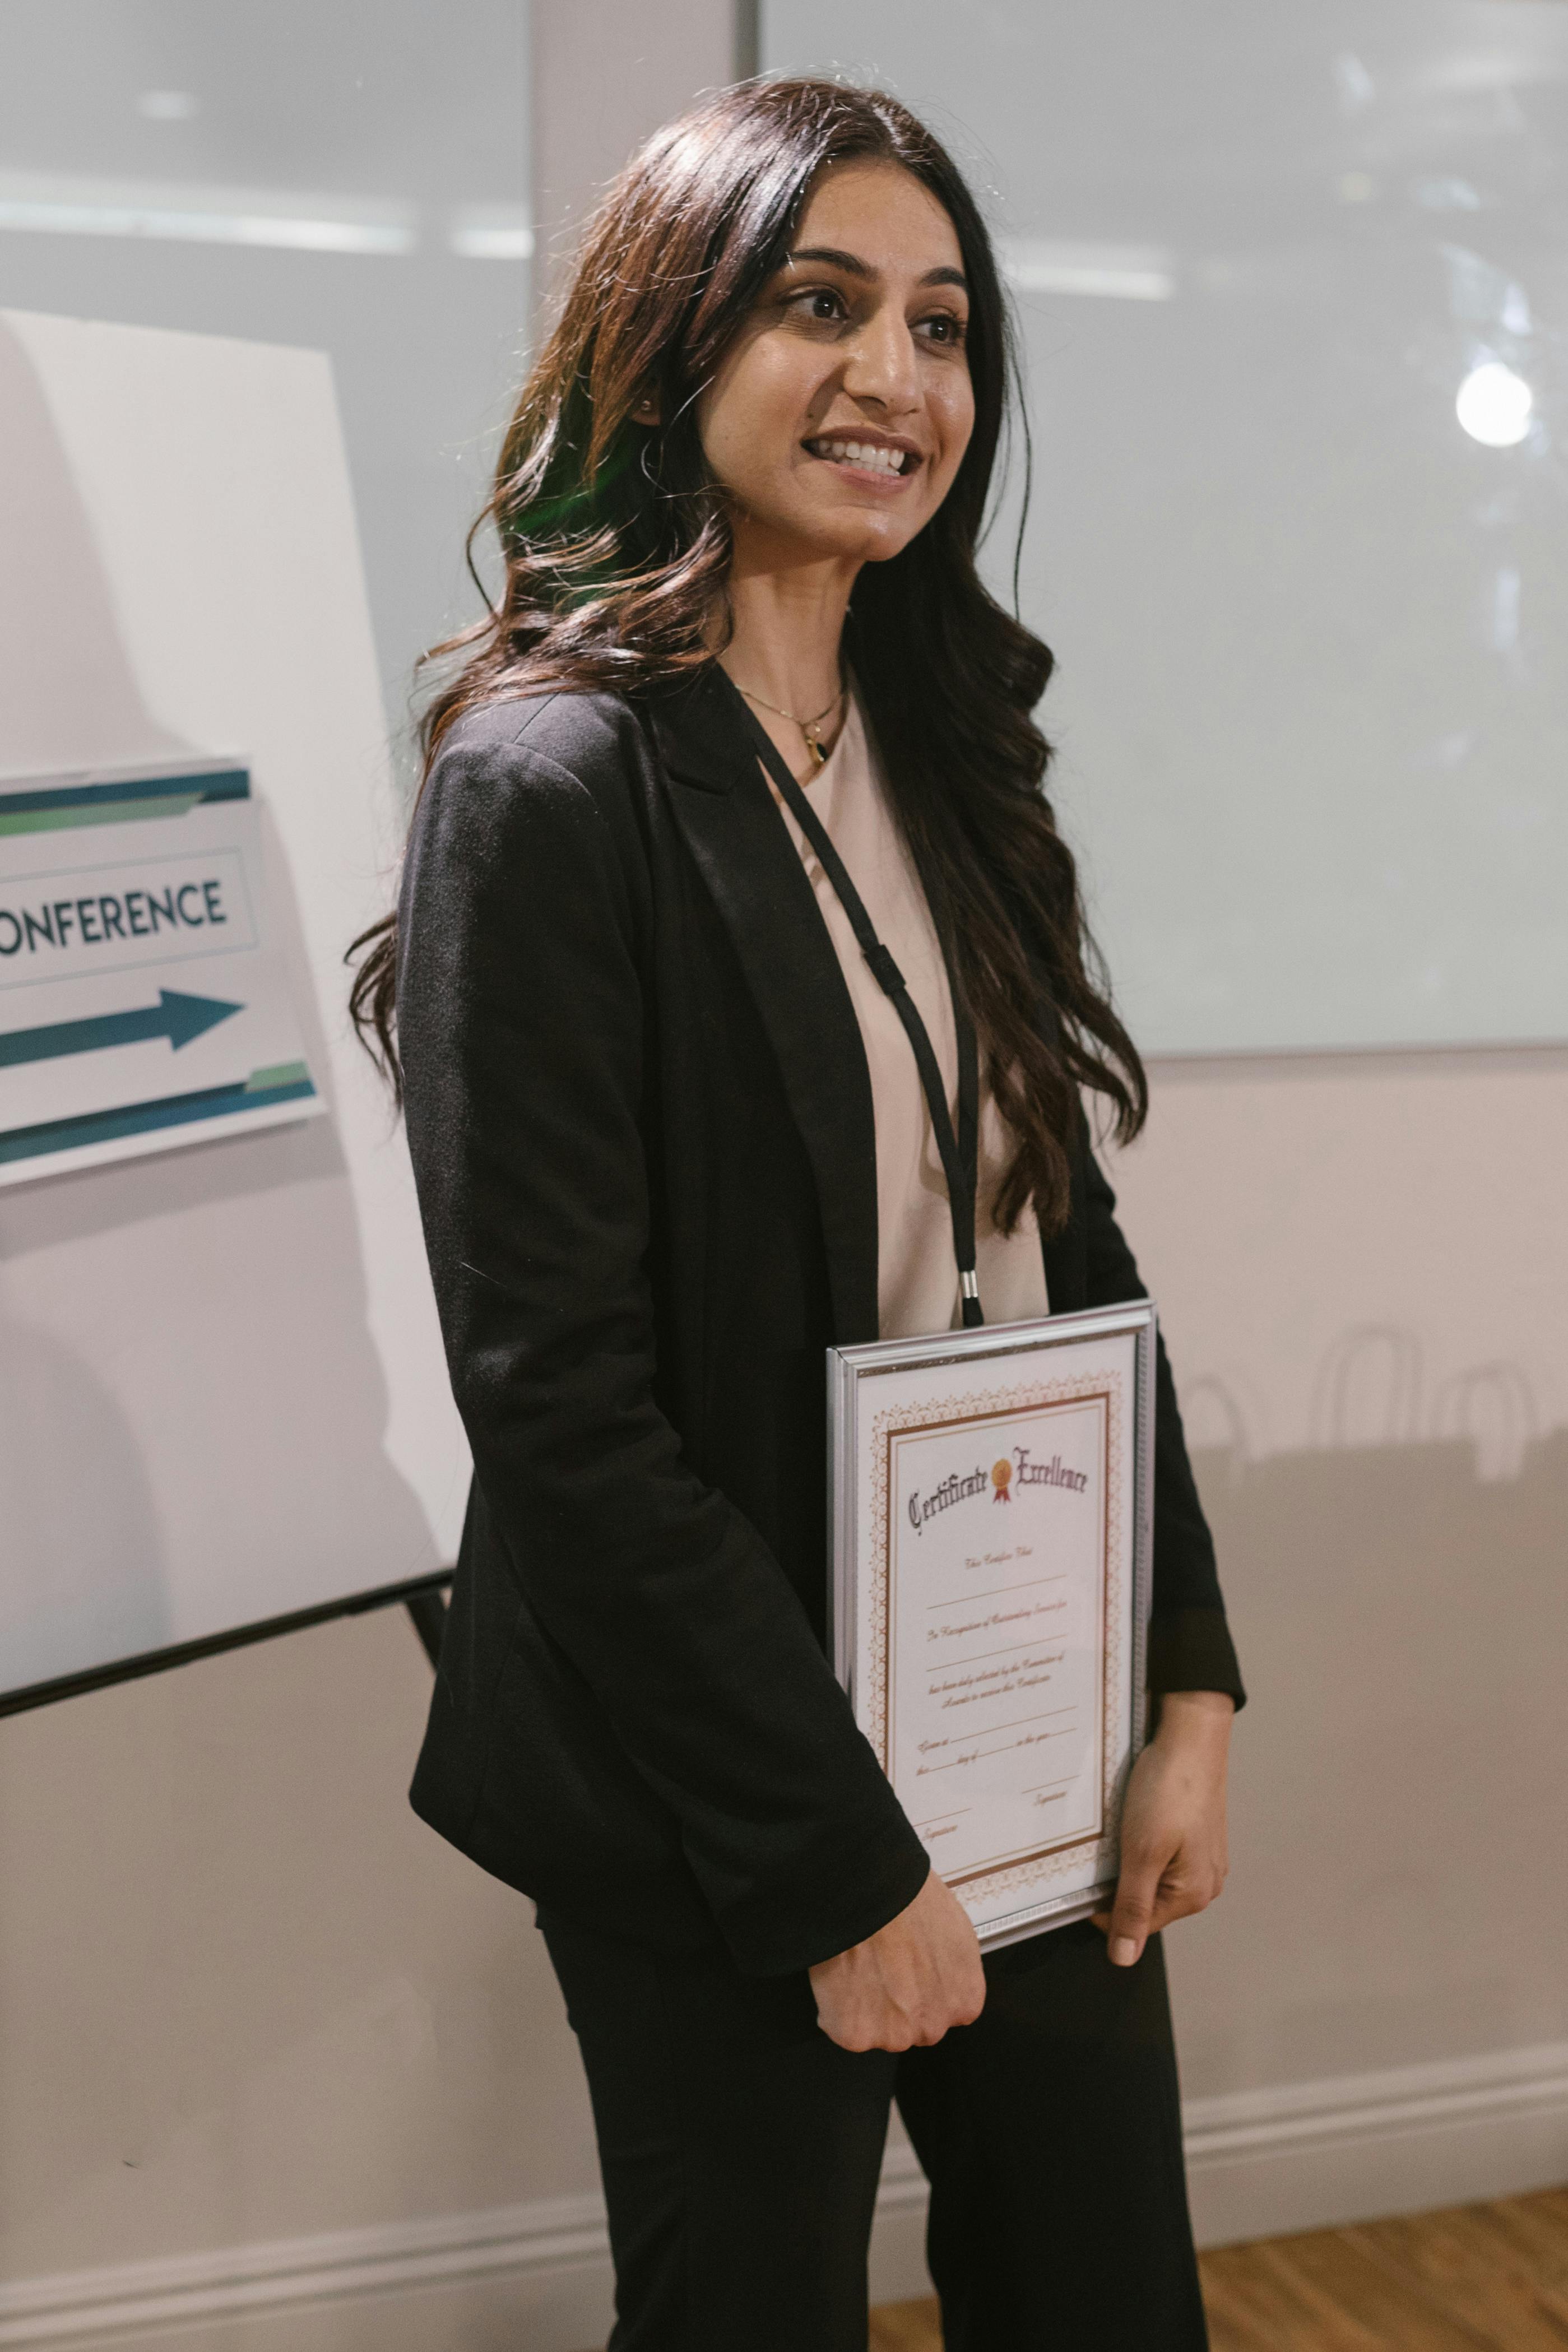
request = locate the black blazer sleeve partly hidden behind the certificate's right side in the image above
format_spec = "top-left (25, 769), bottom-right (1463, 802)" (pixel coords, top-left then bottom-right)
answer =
top-left (1086, 1153), bottom-right (1246, 1708)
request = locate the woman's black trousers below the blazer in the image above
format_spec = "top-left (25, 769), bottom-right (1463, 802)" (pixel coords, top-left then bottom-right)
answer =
top-left (539, 1914), bottom-right (1208, 2352)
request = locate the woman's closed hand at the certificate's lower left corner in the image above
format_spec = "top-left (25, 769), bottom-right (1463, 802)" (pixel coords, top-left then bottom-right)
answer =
top-left (811, 1870), bottom-right (985, 2051)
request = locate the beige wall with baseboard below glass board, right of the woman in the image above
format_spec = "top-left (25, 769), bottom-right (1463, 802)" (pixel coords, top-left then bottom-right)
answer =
top-left (1119, 1051), bottom-right (1568, 2234)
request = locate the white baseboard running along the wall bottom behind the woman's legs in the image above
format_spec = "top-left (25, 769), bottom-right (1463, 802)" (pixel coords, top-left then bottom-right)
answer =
top-left (0, 2042), bottom-right (1568, 2352)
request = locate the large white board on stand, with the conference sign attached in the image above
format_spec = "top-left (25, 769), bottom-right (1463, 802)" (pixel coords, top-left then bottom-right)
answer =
top-left (0, 313), bottom-right (468, 1700)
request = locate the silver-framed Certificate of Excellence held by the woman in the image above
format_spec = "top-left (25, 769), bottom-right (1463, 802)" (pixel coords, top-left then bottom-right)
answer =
top-left (828, 1301), bottom-right (1157, 1950)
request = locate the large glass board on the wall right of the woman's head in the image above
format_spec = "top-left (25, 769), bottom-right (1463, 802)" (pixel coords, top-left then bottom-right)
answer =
top-left (764, 0), bottom-right (1568, 1051)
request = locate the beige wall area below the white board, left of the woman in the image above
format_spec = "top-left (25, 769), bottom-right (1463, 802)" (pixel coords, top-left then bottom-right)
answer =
top-left (0, 1611), bottom-right (595, 2345)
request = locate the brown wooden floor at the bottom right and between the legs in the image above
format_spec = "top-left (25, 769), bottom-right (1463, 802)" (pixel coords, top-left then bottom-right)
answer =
top-left (872, 2189), bottom-right (1568, 2352)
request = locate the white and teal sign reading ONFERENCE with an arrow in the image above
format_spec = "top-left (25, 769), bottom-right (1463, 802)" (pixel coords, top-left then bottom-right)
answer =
top-left (0, 762), bottom-right (324, 1183)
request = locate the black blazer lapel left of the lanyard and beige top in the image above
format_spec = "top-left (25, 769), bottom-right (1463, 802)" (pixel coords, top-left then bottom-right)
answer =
top-left (649, 664), bottom-right (877, 1346)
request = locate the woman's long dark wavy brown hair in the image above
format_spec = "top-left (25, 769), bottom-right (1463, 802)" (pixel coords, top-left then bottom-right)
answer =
top-left (350, 80), bottom-right (1147, 1232)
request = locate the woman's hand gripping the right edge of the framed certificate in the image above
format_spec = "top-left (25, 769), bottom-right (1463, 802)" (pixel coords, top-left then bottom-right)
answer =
top-left (1093, 1691), bottom-right (1237, 1969)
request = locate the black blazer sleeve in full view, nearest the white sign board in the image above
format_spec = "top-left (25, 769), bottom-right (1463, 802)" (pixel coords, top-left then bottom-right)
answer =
top-left (397, 739), bottom-right (929, 1975)
